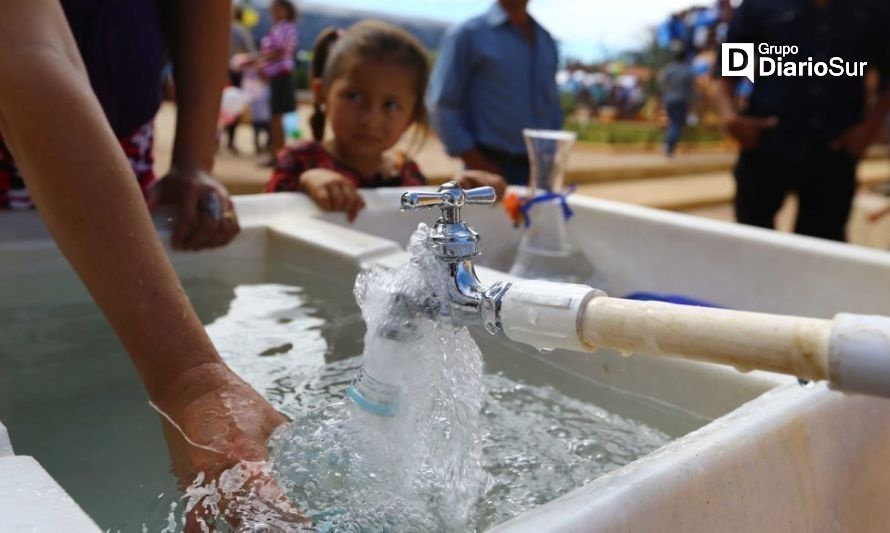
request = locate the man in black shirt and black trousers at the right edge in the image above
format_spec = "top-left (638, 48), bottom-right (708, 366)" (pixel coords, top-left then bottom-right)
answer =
top-left (714, 0), bottom-right (890, 241)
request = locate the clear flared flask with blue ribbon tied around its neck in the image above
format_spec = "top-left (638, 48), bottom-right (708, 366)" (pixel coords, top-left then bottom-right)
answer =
top-left (510, 130), bottom-right (602, 288)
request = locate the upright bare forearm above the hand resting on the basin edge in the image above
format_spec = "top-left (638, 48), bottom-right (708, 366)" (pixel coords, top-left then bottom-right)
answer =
top-left (168, 0), bottom-right (232, 172)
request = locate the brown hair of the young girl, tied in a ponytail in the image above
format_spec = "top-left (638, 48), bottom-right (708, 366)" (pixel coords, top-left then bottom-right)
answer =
top-left (309, 20), bottom-right (430, 141)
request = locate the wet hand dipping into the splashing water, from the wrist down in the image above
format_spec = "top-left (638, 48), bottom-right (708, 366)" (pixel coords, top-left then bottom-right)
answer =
top-left (156, 363), bottom-right (305, 531)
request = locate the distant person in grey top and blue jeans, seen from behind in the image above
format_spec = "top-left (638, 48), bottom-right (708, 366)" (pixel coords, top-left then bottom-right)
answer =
top-left (658, 48), bottom-right (695, 157)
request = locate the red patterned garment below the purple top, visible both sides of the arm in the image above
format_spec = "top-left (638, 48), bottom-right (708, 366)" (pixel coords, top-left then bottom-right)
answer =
top-left (0, 122), bottom-right (157, 210)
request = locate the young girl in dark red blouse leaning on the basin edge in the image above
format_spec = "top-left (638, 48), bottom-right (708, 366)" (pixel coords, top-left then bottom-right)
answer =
top-left (266, 21), bottom-right (506, 221)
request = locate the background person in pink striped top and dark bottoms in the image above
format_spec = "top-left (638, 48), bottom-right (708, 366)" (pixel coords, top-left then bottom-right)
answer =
top-left (259, 0), bottom-right (297, 167)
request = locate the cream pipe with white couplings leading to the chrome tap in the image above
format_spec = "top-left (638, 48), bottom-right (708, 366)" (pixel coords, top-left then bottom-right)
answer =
top-left (501, 281), bottom-right (890, 396)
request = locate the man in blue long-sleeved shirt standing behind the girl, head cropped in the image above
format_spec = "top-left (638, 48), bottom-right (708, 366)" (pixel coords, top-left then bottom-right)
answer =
top-left (427, 0), bottom-right (562, 185)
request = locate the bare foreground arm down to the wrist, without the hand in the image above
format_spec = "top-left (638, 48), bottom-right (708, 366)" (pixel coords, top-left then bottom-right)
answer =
top-left (0, 1), bottom-right (219, 398)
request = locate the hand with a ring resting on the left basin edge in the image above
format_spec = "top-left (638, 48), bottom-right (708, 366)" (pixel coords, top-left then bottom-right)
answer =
top-left (148, 169), bottom-right (241, 251)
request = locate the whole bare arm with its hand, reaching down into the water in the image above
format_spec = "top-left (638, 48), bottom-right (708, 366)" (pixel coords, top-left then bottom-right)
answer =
top-left (0, 0), bottom-right (284, 496)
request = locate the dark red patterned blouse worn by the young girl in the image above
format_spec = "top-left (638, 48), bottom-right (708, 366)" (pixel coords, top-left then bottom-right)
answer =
top-left (266, 141), bottom-right (426, 192)
